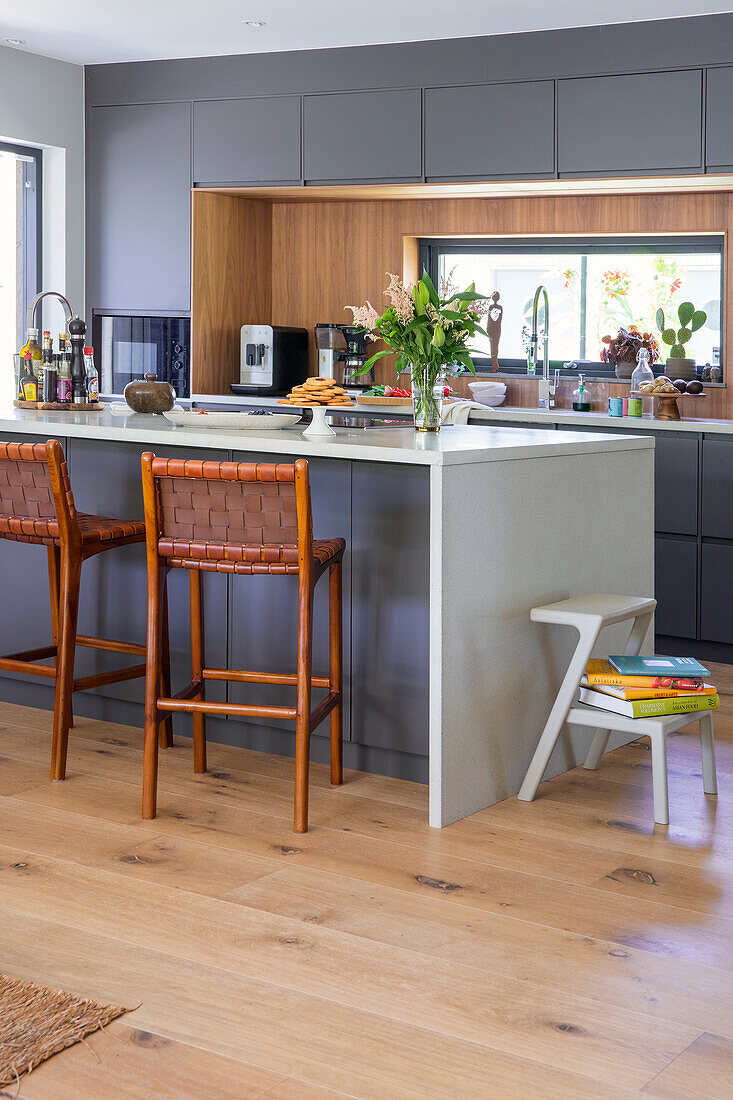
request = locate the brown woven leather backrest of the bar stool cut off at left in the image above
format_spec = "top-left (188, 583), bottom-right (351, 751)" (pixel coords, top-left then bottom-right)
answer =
top-left (0, 443), bottom-right (74, 519)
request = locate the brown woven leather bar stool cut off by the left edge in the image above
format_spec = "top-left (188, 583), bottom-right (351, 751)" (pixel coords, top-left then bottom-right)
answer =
top-left (0, 439), bottom-right (173, 780)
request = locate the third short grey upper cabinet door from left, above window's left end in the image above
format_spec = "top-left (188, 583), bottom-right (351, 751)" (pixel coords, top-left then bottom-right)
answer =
top-left (425, 80), bottom-right (555, 179)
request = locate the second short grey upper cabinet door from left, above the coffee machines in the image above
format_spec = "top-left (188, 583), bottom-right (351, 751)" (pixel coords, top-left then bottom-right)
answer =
top-left (303, 88), bottom-right (423, 183)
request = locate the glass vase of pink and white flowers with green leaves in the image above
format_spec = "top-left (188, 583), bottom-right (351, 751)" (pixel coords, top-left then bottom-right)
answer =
top-left (346, 271), bottom-right (488, 431)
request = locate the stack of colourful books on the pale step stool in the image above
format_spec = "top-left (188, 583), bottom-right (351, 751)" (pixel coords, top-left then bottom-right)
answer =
top-left (580, 657), bottom-right (720, 718)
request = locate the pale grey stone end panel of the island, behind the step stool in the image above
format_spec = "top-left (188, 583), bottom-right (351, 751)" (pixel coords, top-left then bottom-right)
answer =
top-left (430, 447), bottom-right (654, 826)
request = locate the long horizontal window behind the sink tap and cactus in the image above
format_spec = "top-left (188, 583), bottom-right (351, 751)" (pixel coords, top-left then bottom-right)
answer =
top-left (420, 234), bottom-right (723, 375)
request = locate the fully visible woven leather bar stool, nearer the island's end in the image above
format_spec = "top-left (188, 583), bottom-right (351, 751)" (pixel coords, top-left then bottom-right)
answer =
top-left (142, 452), bottom-right (346, 833)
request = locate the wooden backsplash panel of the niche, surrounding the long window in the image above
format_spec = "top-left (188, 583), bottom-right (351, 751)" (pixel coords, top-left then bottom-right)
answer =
top-left (194, 191), bottom-right (733, 417)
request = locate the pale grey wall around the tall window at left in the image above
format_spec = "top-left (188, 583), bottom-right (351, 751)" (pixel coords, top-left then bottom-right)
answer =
top-left (0, 46), bottom-right (84, 327)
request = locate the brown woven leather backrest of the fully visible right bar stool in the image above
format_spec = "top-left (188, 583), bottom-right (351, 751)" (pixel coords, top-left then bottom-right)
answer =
top-left (153, 459), bottom-right (298, 547)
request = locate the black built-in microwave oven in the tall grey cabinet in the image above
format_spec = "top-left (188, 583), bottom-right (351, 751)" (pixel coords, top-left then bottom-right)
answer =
top-left (91, 314), bottom-right (190, 397)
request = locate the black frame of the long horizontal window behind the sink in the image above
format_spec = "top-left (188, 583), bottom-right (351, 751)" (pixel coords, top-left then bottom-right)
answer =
top-left (418, 232), bottom-right (725, 378)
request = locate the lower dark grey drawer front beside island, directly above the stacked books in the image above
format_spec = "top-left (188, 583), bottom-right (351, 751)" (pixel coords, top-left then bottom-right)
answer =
top-left (654, 536), bottom-right (698, 638)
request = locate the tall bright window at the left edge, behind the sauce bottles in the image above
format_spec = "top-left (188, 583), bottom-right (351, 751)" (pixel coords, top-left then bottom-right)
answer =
top-left (0, 142), bottom-right (42, 397)
